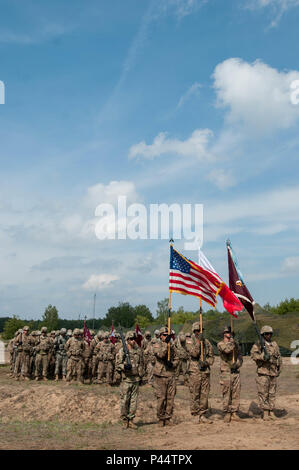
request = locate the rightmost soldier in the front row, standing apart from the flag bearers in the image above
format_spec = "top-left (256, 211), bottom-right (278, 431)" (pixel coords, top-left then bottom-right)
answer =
top-left (251, 325), bottom-right (282, 421)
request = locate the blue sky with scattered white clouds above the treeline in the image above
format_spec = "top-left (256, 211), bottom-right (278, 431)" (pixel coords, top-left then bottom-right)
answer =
top-left (0, 0), bottom-right (299, 318)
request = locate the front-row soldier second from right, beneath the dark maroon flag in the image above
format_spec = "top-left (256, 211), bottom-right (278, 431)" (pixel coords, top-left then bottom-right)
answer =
top-left (217, 326), bottom-right (243, 423)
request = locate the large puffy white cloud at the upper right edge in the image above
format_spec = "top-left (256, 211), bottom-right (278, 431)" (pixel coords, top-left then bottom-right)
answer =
top-left (213, 58), bottom-right (299, 134)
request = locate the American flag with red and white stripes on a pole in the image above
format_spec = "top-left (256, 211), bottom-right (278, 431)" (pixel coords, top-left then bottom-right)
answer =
top-left (169, 246), bottom-right (224, 308)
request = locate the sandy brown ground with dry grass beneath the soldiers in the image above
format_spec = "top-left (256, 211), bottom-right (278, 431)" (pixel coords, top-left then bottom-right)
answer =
top-left (0, 358), bottom-right (299, 450)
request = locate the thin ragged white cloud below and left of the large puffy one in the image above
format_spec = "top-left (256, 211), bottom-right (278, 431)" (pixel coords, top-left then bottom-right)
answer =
top-left (129, 129), bottom-right (213, 160)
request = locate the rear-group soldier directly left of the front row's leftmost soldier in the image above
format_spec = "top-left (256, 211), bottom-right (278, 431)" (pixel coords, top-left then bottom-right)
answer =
top-left (95, 331), bottom-right (115, 385)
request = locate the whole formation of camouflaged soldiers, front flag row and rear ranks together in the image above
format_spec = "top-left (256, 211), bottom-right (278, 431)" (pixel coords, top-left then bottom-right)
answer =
top-left (8, 322), bottom-right (282, 428)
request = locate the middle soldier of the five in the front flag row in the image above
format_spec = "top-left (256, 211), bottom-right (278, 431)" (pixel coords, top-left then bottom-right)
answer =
top-left (186, 322), bottom-right (214, 424)
